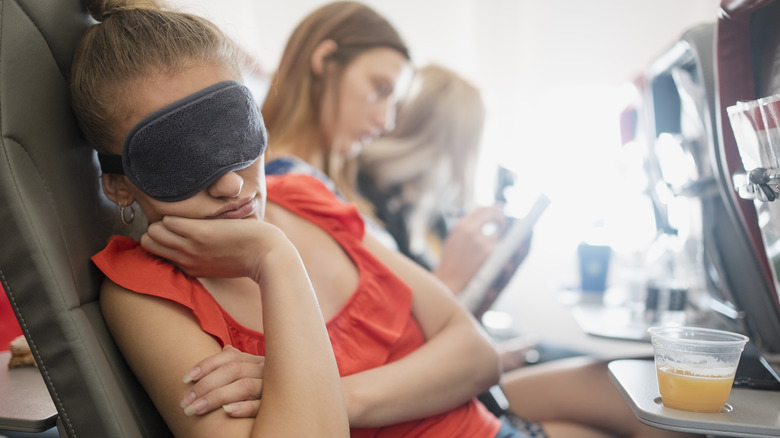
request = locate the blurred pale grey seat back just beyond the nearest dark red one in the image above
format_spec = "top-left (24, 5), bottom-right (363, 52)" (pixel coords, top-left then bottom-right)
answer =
top-left (634, 21), bottom-right (756, 338)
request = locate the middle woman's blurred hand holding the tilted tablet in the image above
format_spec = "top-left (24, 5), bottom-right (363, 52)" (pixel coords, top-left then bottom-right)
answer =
top-left (433, 204), bottom-right (506, 294)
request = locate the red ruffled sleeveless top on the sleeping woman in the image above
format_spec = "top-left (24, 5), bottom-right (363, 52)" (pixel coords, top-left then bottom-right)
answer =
top-left (92, 175), bottom-right (501, 438)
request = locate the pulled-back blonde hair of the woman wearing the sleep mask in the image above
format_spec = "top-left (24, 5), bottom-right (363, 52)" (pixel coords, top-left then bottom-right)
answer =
top-left (70, 0), bottom-right (240, 152)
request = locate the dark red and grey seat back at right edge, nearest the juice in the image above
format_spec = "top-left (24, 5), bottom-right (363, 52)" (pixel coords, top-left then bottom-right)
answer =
top-left (715, 0), bottom-right (780, 355)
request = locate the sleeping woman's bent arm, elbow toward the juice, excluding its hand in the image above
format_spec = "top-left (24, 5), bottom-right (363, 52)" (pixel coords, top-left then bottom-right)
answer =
top-left (342, 236), bottom-right (501, 427)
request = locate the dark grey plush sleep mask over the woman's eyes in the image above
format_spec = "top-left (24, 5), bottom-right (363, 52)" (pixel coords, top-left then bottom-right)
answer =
top-left (98, 81), bottom-right (267, 202)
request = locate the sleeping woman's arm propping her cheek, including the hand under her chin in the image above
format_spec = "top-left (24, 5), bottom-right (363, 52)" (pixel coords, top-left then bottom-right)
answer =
top-left (100, 218), bottom-right (349, 437)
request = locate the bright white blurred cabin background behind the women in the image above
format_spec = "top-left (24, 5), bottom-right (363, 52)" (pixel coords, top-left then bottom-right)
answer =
top-left (171, 0), bottom-right (720, 356)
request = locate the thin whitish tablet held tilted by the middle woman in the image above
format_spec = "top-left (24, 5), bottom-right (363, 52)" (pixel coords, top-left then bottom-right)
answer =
top-left (458, 194), bottom-right (550, 313)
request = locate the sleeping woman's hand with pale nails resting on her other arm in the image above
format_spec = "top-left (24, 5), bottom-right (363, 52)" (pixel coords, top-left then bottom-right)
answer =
top-left (181, 345), bottom-right (265, 418)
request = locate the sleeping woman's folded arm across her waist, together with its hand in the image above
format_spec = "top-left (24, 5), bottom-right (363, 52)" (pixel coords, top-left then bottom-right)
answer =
top-left (178, 226), bottom-right (500, 427)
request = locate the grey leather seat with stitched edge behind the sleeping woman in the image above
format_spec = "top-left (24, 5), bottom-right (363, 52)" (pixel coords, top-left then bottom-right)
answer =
top-left (0, 0), bottom-right (171, 437)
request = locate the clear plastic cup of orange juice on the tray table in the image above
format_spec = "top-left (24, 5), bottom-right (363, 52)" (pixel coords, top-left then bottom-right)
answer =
top-left (648, 326), bottom-right (748, 412)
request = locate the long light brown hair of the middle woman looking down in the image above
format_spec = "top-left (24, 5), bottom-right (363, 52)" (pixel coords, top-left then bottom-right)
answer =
top-left (262, 1), bottom-right (409, 183)
